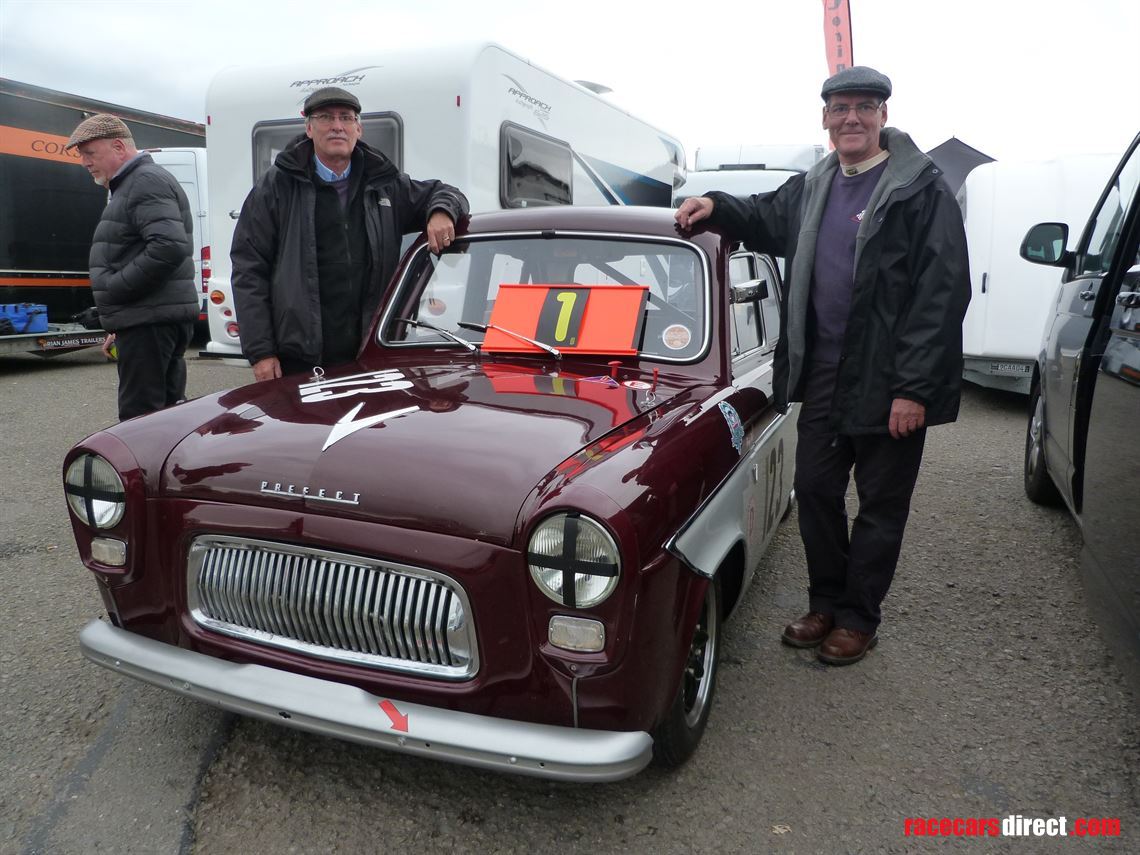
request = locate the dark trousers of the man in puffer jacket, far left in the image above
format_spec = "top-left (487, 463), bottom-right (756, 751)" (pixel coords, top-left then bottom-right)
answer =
top-left (115, 323), bottom-right (194, 422)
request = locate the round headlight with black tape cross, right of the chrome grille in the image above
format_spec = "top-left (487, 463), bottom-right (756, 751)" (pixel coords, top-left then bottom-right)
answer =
top-left (527, 512), bottom-right (621, 609)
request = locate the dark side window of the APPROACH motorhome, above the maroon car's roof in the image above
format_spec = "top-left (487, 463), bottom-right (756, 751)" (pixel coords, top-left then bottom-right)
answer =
top-left (500, 124), bottom-right (573, 207)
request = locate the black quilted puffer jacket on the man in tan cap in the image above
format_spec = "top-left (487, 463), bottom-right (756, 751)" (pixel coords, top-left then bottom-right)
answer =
top-left (89, 154), bottom-right (200, 333)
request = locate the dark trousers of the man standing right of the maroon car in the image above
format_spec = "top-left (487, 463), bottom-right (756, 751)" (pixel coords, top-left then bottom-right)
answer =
top-left (796, 364), bottom-right (926, 633)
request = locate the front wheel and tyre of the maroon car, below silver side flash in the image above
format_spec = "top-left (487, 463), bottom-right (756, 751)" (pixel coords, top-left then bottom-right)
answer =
top-left (653, 576), bottom-right (722, 768)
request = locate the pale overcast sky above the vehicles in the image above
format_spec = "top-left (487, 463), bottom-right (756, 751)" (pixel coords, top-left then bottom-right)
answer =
top-left (0, 0), bottom-right (1140, 161)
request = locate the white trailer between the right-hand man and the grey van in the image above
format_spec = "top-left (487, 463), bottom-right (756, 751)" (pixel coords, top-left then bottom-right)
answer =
top-left (958, 154), bottom-right (1117, 394)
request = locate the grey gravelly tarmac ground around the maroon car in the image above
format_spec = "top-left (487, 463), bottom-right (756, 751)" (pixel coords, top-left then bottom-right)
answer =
top-left (0, 353), bottom-right (1140, 855)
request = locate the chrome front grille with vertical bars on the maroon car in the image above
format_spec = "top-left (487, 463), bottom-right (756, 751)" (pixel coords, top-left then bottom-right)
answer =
top-left (186, 535), bottom-right (479, 679)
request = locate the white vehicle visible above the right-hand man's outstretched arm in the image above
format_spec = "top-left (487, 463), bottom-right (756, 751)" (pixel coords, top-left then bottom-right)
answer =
top-left (673, 145), bottom-right (823, 207)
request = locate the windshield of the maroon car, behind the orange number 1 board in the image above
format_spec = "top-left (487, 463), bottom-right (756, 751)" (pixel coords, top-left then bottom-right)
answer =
top-left (381, 235), bottom-right (708, 361)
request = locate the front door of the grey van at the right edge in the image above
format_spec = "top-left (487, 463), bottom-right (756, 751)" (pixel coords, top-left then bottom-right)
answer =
top-left (1041, 141), bottom-right (1140, 501)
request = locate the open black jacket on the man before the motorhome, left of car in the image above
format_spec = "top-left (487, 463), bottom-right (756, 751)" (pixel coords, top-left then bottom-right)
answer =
top-left (230, 137), bottom-right (467, 365)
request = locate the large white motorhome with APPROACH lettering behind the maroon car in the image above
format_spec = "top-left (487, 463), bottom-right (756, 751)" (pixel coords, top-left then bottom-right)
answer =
top-left (204, 42), bottom-right (685, 356)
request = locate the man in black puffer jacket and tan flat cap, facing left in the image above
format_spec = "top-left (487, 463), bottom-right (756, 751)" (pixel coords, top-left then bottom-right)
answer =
top-left (67, 113), bottom-right (198, 420)
